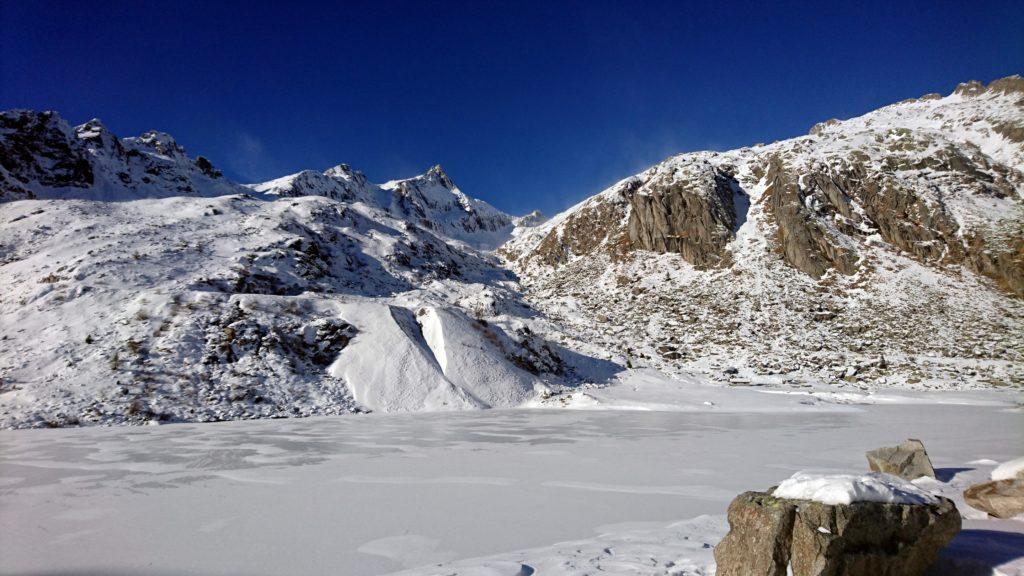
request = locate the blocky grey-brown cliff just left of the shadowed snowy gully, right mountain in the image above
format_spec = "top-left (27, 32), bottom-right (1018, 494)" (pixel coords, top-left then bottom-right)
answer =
top-left (628, 165), bottom-right (738, 268)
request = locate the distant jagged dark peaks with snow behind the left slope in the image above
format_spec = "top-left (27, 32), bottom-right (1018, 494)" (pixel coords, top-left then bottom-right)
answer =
top-left (0, 110), bottom-right (537, 250)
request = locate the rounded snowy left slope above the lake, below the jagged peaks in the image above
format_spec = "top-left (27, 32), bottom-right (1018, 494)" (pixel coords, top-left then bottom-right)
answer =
top-left (0, 195), bottom-right (577, 425)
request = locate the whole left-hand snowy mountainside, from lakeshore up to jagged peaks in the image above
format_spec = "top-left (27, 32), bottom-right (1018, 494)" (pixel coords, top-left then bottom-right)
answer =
top-left (0, 111), bottom-right (602, 426)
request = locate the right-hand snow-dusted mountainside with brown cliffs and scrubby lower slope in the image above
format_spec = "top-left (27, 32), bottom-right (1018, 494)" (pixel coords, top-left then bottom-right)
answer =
top-left (502, 77), bottom-right (1024, 387)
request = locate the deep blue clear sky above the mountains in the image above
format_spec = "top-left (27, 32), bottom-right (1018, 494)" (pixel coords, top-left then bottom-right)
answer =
top-left (0, 0), bottom-right (1024, 213)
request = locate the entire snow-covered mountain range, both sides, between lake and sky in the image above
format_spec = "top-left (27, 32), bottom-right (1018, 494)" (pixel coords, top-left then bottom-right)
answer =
top-left (0, 77), bottom-right (1024, 426)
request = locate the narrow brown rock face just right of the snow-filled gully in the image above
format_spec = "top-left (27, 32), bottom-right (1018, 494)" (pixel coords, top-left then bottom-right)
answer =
top-left (763, 159), bottom-right (857, 278)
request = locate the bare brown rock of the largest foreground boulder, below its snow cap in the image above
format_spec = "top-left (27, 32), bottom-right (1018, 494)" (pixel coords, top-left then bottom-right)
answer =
top-left (715, 491), bottom-right (961, 576)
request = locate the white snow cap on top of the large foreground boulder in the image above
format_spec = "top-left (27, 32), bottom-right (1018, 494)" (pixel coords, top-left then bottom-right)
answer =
top-left (772, 472), bottom-right (938, 504)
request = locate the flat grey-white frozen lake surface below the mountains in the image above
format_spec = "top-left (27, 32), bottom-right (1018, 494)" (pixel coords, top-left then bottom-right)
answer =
top-left (0, 397), bottom-right (1024, 576)
